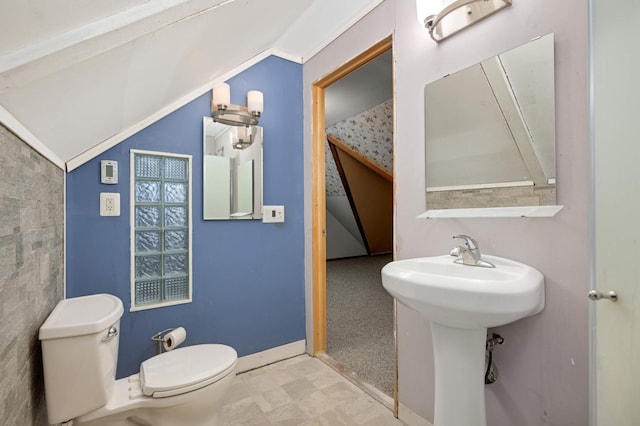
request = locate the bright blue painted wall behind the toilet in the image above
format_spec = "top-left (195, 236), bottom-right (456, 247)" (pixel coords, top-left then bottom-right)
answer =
top-left (67, 56), bottom-right (305, 377)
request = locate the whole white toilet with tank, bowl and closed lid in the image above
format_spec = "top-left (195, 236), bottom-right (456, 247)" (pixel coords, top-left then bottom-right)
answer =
top-left (40, 294), bottom-right (238, 426)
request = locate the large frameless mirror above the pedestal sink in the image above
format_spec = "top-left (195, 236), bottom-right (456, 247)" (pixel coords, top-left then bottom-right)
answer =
top-left (424, 34), bottom-right (556, 210)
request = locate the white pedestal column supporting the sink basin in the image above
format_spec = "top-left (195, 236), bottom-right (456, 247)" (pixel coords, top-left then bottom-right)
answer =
top-left (431, 322), bottom-right (487, 426)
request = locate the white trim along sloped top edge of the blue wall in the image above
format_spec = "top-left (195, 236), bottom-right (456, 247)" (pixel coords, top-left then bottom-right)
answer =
top-left (66, 49), bottom-right (302, 172)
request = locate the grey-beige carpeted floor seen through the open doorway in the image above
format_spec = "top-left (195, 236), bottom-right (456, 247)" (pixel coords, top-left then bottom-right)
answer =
top-left (327, 255), bottom-right (394, 397)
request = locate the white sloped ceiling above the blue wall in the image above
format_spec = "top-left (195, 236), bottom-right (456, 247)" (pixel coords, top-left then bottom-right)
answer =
top-left (0, 0), bottom-right (381, 166)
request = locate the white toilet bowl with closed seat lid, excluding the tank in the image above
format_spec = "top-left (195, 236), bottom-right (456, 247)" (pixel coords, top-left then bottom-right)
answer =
top-left (74, 345), bottom-right (237, 426)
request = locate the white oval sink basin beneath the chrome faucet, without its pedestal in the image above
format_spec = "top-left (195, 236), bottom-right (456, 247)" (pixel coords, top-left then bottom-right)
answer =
top-left (382, 255), bottom-right (544, 328)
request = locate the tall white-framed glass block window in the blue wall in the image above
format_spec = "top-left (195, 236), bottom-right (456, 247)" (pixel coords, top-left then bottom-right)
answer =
top-left (131, 150), bottom-right (191, 311)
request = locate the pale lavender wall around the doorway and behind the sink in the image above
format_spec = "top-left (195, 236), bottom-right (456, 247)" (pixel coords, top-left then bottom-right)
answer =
top-left (303, 0), bottom-right (590, 426)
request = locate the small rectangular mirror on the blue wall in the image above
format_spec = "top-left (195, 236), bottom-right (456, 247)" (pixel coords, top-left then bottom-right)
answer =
top-left (202, 117), bottom-right (262, 220)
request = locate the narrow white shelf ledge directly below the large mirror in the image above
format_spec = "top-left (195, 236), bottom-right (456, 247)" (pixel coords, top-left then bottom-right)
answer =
top-left (417, 206), bottom-right (564, 219)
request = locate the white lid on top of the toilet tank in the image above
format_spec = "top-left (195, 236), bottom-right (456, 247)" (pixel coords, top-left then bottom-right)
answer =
top-left (40, 294), bottom-right (124, 340)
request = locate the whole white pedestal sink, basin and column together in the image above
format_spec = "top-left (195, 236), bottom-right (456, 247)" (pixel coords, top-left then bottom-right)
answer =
top-left (382, 255), bottom-right (544, 426)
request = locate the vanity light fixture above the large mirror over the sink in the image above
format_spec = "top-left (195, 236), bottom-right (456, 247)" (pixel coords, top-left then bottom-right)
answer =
top-left (416, 0), bottom-right (512, 43)
